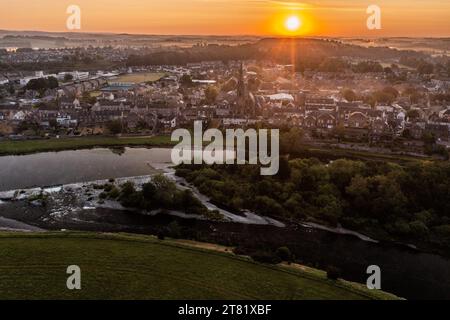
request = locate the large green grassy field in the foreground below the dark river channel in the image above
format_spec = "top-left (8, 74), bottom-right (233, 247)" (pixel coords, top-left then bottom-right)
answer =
top-left (0, 233), bottom-right (395, 299)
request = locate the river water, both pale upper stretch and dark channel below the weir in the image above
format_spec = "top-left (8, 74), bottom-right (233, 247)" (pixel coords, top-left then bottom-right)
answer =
top-left (0, 148), bottom-right (450, 299)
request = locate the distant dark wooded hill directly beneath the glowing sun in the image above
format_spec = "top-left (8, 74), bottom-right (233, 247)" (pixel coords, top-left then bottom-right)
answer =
top-left (127, 38), bottom-right (426, 66)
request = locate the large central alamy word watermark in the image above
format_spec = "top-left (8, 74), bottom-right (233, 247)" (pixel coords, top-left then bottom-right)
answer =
top-left (171, 121), bottom-right (280, 176)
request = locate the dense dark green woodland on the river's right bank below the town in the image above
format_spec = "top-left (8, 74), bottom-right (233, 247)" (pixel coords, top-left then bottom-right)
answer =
top-left (177, 158), bottom-right (450, 247)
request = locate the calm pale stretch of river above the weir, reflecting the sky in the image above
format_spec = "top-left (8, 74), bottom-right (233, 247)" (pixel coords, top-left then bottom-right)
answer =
top-left (0, 148), bottom-right (171, 191)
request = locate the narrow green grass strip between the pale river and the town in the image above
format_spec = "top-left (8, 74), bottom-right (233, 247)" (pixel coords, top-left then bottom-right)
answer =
top-left (0, 136), bottom-right (174, 155)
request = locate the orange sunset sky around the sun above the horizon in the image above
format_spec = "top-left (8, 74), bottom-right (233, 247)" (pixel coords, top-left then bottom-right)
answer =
top-left (0, 0), bottom-right (450, 36)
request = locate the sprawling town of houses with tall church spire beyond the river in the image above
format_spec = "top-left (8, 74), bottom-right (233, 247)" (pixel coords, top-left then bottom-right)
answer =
top-left (0, 39), bottom-right (450, 157)
